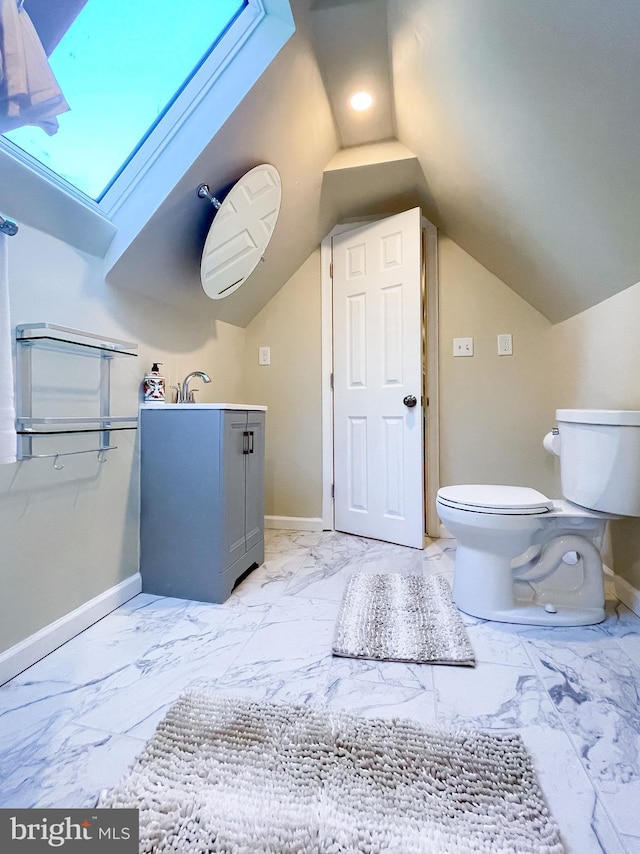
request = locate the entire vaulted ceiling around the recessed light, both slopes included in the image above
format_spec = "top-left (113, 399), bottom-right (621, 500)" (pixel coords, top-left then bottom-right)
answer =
top-left (109, 0), bottom-right (640, 325)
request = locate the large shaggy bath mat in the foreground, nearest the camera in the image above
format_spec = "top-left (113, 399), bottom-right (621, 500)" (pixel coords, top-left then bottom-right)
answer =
top-left (98, 693), bottom-right (564, 854)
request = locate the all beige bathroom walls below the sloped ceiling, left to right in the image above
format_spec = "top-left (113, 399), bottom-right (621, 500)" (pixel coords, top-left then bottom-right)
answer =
top-left (7, 214), bottom-right (640, 650)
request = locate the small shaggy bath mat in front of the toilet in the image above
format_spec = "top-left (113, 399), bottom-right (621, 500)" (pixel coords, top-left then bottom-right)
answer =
top-left (333, 573), bottom-right (476, 667)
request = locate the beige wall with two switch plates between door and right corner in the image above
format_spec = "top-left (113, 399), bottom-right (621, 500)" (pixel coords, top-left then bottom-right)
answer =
top-left (439, 236), bottom-right (557, 494)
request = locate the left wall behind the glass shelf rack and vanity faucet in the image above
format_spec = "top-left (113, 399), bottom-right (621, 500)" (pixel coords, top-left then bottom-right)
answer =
top-left (0, 226), bottom-right (244, 650)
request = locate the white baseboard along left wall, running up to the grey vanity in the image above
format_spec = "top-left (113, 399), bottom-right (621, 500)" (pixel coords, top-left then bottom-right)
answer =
top-left (0, 572), bottom-right (142, 685)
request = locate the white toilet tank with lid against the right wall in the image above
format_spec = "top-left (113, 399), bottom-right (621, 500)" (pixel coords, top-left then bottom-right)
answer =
top-left (556, 409), bottom-right (640, 516)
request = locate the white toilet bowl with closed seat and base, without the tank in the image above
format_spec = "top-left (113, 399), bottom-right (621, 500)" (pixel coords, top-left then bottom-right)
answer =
top-left (437, 484), bottom-right (612, 626)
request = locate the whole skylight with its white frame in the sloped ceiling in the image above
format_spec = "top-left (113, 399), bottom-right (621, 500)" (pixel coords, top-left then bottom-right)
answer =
top-left (0, 0), bottom-right (295, 260)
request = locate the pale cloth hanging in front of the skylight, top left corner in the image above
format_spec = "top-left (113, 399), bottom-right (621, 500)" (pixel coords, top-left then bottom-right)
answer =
top-left (0, 0), bottom-right (69, 136)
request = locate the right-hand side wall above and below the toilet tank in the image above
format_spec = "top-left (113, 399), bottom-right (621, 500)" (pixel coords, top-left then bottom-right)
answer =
top-left (553, 283), bottom-right (640, 590)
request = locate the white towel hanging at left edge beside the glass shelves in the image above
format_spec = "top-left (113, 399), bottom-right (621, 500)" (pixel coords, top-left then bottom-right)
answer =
top-left (0, 234), bottom-right (16, 463)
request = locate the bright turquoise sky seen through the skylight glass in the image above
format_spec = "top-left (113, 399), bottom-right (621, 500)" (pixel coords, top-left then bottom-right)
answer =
top-left (4, 0), bottom-right (246, 199)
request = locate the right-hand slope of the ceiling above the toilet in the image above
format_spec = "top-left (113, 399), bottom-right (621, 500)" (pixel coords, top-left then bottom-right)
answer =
top-left (389, 0), bottom-right (640, 322)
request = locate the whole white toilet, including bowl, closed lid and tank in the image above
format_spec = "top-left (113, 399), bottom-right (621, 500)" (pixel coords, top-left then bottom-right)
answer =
top-left (436, 409), bottom-right (640, 626)
